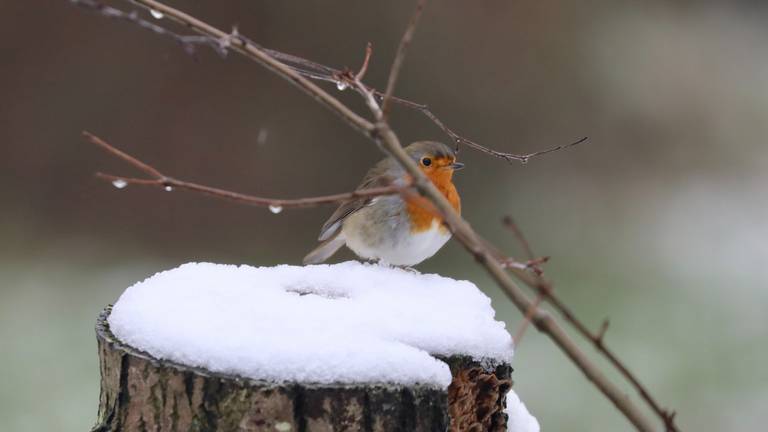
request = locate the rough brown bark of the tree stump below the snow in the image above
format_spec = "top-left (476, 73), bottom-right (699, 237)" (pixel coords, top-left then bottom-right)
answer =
top-left (93, 307), bottom-right (512, 432)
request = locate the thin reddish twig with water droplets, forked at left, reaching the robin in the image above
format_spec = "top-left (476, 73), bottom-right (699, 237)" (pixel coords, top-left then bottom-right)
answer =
top-left (83, 131), bottom-right (412, 213)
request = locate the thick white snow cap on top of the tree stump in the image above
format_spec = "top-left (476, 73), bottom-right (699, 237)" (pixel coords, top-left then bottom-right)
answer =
top-left (108, 261), bottom-right (512, 387)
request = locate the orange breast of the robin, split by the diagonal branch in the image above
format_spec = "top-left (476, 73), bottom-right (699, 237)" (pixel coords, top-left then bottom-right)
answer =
top-left (406, 170), bottom-right (461, 232)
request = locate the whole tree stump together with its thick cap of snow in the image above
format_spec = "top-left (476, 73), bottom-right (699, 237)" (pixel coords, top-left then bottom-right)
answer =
top-left (93, 262), bottom-right (520, 432)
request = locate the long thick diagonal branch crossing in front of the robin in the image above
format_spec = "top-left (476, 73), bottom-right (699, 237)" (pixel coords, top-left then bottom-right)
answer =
top-left (76, 0), bottom-right (675, 431)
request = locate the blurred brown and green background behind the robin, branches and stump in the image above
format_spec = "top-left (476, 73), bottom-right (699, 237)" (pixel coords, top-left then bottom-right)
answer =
top-left (0, 0), bottom-right (768, 431)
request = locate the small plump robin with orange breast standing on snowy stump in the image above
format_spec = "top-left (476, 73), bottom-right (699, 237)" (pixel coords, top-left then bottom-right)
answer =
top-left (304, 141), bottom-right (464, 268)
